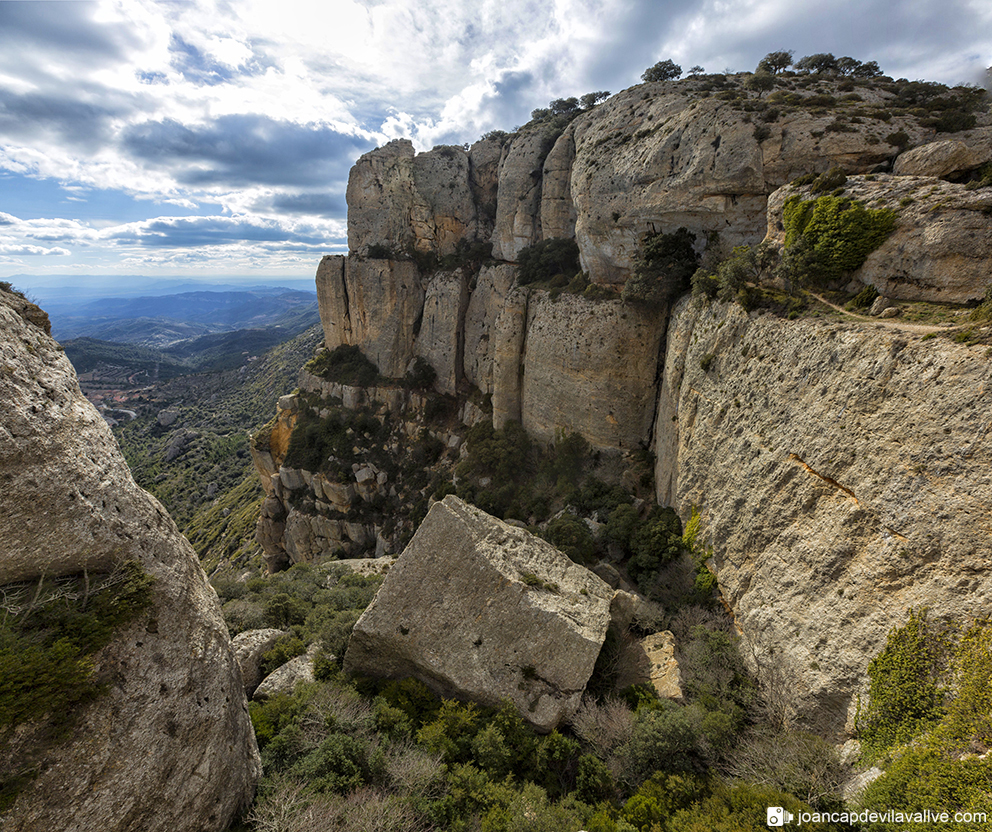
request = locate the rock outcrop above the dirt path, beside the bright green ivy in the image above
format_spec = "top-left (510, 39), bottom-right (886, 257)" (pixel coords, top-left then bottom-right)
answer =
top-left (765, 174), bottom-right (992, 303)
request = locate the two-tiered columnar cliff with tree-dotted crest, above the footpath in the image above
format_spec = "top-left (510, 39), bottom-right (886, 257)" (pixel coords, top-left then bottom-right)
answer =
top-left (317, 78), bottom-right (992, 450)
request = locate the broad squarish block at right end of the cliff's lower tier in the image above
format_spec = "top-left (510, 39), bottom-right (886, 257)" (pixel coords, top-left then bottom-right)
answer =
top-left (520, 292), bottom-right (665, 450)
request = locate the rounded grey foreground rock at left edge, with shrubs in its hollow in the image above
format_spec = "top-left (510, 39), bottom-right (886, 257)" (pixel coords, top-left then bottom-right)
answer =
top-left (0, 290), bottom-right (261, 832)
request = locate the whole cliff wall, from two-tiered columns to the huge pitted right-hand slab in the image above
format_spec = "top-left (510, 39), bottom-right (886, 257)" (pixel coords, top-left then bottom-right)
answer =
top-left (274, 78), bottom-right (992, 731)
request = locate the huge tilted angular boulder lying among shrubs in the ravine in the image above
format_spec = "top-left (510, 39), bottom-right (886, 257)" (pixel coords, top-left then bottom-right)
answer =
top-left (344, 496), bottom-right (615, 731)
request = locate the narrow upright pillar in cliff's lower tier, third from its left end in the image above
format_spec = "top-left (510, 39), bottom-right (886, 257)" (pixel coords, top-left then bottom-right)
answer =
top-left (414, 269), bottom-right (468, 395)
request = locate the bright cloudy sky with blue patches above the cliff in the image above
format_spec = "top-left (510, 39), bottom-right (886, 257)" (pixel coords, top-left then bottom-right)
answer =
top-left (0, 0), bottom-right (992, 278)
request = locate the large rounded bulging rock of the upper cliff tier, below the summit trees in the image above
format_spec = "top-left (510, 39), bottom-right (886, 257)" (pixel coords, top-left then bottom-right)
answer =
top-left (564, 84), bottom-right (926, 284)
